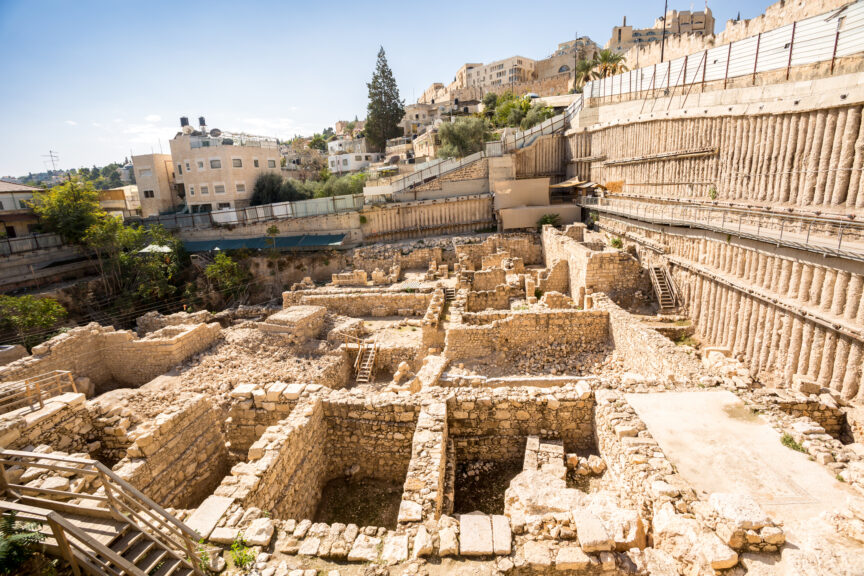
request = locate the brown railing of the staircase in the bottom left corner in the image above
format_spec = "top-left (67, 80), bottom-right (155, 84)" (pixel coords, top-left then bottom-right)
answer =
top-left (0, 450), bottom-right (204, 576)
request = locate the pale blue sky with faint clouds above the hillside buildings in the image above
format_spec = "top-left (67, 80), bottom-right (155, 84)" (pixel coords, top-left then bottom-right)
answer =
top-left (0, 0), bottom-right (770, 176)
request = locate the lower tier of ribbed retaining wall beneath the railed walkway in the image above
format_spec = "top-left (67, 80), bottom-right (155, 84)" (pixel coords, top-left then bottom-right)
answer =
top-left (602, 218), bottom-right (864, 400)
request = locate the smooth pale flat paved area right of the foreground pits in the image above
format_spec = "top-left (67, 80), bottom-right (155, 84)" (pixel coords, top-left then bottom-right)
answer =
top-left (626, 390), bottom-right (864, 576)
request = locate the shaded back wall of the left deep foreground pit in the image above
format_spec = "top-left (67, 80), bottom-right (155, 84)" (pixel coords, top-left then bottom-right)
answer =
top-left (325, 393), bottom-right (420, 483)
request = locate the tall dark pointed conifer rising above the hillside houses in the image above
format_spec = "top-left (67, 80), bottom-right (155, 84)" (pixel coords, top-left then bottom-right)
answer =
top-left (364, 47), bottom-right (405, 150)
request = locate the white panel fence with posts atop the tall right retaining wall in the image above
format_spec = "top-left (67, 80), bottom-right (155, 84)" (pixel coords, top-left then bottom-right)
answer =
top-left (583, 0), bottom-right (864, 98)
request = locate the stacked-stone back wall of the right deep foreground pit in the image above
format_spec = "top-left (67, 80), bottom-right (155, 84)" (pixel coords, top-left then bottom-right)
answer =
top-left (447, 385), bottom-right (595, 462)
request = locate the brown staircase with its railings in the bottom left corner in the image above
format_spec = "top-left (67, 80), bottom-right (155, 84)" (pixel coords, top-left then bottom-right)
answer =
top-left (0, 450), bottom-right (205, 576)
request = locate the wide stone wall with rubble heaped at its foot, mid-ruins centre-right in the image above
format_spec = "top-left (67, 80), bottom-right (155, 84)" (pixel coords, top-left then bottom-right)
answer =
top-left (444, 310), bottom-right (608, 360)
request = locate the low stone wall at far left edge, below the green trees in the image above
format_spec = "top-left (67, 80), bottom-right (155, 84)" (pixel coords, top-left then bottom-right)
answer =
top-left (0, 322), bottom-right (221, 394)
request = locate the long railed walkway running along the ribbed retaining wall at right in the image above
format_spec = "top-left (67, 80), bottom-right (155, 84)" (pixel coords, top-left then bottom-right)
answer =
top-left (579, 197), bottom-right (864, 261)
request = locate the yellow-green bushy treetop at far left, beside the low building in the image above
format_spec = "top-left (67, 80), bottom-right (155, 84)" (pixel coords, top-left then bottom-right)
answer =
top-left (33, 179), bottom-right (105, 244)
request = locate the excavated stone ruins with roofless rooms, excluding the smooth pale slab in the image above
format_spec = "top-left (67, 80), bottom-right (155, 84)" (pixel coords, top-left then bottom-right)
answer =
top-left (0, 231), bottom-right (864, 576)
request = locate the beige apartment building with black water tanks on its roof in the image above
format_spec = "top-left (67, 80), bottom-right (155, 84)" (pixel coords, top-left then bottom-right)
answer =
top-left (170, 117), bottom-right (282, 213)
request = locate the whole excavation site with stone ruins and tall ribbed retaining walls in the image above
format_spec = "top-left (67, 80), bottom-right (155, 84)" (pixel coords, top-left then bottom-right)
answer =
top-left (0, 2), bottom-right (864, 576)
